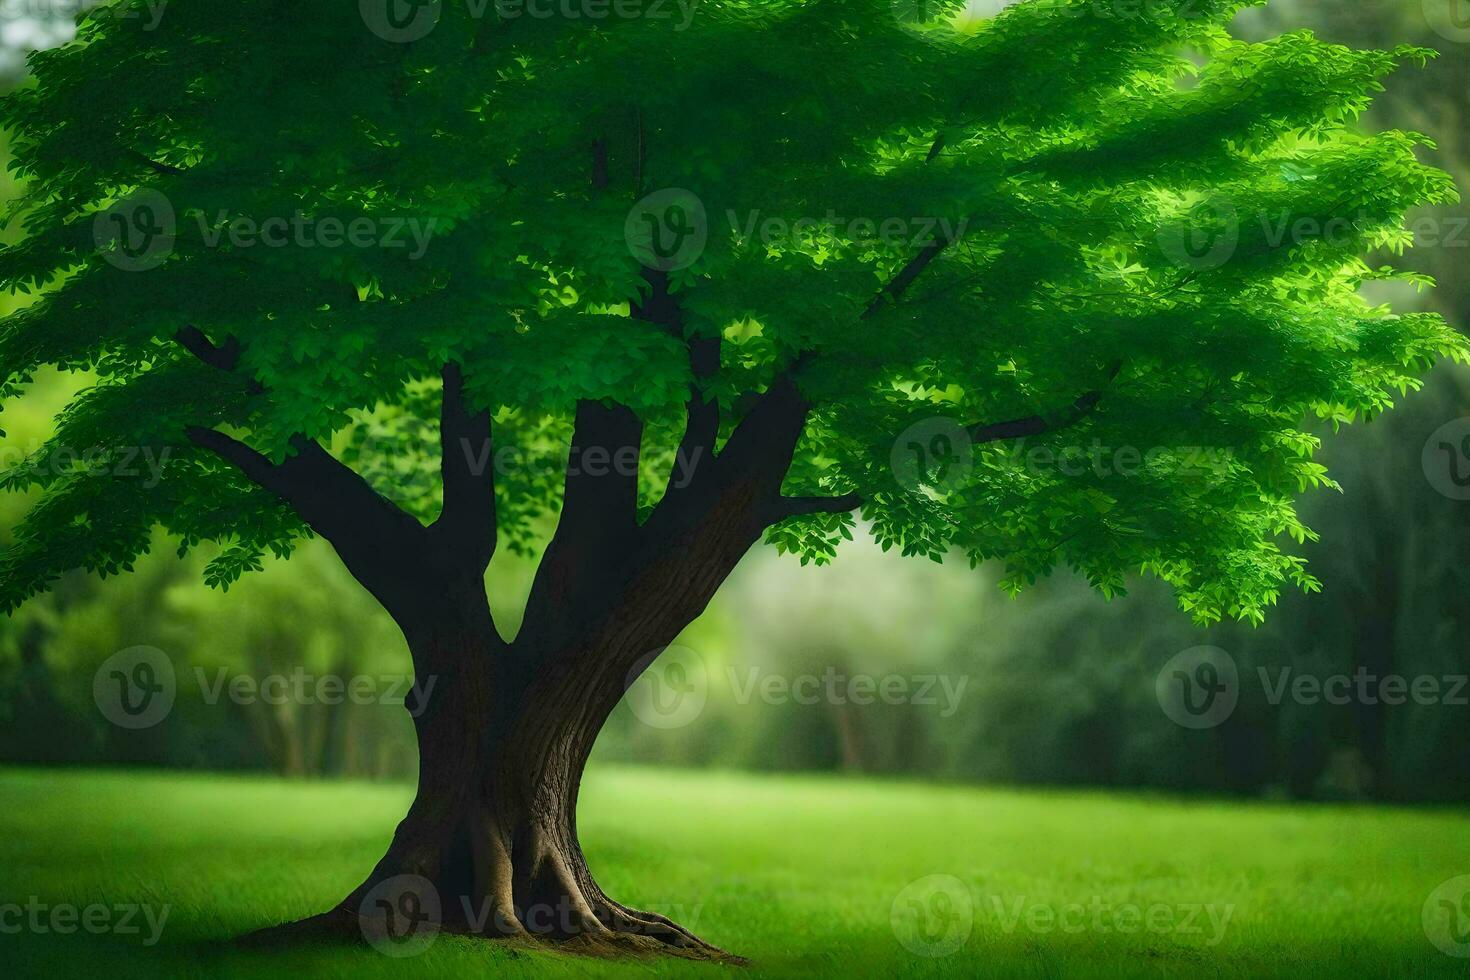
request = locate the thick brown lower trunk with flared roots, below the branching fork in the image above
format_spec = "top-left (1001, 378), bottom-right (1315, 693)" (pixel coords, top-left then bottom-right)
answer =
top-left (254, 570), bottom-right (746, 959)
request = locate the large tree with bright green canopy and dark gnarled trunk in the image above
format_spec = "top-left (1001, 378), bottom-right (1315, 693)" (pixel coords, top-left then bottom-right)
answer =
top-left (0, 0), bottom-right (1464, 952)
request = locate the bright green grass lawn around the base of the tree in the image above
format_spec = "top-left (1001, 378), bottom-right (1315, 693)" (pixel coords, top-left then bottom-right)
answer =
top-left (0, 767), bottom-right (1470, 980)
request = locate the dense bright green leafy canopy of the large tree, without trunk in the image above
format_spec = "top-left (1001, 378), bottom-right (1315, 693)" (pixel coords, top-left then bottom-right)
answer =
top-left (0, 0), bottom-right (1466, 621)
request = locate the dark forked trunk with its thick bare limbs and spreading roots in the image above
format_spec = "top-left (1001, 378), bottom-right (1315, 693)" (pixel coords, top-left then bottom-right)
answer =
top-left (235, 357), bottom-right (823, 959)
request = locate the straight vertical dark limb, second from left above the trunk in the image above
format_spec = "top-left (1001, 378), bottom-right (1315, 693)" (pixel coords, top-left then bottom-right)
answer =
top-left (429, 363), bottom-right (495, 564)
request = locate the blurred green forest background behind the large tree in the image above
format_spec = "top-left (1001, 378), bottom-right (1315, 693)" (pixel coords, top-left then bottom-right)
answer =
top-left (0, 0), bottom-right (1470, 801)
